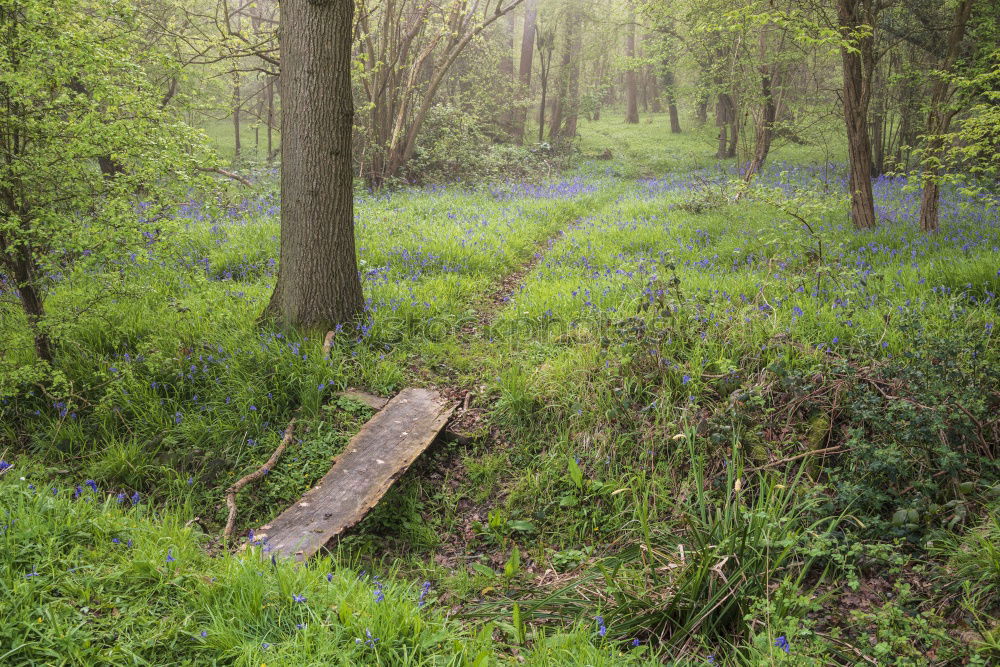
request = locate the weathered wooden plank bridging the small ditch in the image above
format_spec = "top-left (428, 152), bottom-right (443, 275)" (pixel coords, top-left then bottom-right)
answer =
top-left (256, 389), bottom-right (455, 561)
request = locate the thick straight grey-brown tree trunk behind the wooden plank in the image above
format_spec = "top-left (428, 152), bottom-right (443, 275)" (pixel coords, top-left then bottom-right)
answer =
top-left (265, 0), bottom-right (363, 331)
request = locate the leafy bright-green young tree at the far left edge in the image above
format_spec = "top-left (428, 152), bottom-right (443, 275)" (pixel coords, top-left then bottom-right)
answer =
top-left (0, 0), bottom-right (207, 360)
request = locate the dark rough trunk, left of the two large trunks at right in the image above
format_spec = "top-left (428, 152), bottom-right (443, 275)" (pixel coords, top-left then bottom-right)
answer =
top-left (836, 0), bottom-right (876, 229)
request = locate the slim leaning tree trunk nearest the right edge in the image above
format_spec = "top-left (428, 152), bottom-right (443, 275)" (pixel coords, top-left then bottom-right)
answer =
top-left (920, 0), bottom-right (973, 232)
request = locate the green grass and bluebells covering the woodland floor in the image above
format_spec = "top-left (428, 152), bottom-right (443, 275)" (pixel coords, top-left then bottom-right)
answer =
top-left (0, 116), bottom-right (1000, 665)
